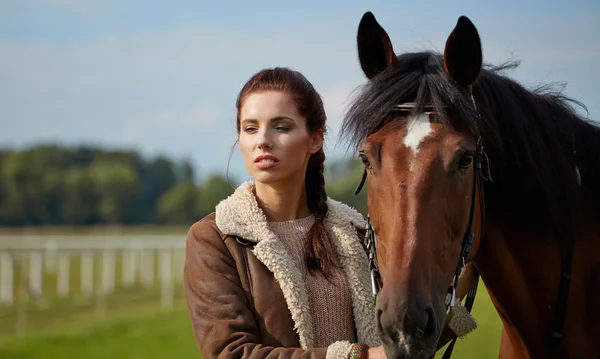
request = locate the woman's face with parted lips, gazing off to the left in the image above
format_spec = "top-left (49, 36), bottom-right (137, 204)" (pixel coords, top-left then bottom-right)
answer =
top-left (238, 91), bottom-right (323, 184)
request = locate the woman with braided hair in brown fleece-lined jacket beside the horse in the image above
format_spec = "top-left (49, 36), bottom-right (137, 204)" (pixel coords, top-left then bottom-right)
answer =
top-left (184, 68), bottom-right (385, 359)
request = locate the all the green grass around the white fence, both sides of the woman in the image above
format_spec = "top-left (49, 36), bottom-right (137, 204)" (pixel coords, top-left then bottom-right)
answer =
top-left (0, 227), bottom-right (501, 359)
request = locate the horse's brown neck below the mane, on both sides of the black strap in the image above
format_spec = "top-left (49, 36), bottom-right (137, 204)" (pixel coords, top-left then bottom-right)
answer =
top-left (475, 214), bottom-right (600, 358)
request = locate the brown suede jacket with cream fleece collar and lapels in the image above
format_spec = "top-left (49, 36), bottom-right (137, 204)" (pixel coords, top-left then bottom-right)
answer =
top-left (184, 182), bottom-right (379, 359)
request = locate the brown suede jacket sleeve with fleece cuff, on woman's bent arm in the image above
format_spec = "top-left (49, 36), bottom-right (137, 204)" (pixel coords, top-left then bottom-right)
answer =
top-left (183, 221), bottom-right (351, 359)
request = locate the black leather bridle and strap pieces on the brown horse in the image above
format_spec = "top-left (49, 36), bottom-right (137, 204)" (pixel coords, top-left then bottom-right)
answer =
top-left (354, 99), bottom-right (581, 359)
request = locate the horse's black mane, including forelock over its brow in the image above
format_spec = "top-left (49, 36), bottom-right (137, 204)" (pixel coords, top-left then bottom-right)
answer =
top-left (341, 52), bottom-right (600, 239)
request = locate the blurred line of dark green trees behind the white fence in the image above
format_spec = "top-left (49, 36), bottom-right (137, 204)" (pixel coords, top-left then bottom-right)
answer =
top-left (0, 144), bottom-right (366, 227)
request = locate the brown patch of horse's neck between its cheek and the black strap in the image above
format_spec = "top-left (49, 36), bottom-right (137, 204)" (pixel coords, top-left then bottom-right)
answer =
top-left (475, 221), bottom-right (561, 357)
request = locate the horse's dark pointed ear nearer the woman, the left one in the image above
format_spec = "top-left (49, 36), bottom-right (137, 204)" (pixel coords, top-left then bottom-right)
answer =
top-left (356, 11), bottom-right (396, 79)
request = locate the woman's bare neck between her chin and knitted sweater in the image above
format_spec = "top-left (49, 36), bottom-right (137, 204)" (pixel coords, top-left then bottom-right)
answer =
top-left (254, 182), bottom-right (310, 222)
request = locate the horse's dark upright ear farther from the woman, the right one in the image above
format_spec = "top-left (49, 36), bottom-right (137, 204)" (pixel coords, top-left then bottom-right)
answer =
top-left (444, 16), bottom-right (483, 87)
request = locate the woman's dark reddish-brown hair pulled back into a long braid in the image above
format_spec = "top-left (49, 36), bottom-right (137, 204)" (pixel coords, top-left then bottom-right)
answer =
top-left (236, 67), bottom-right (337, 279)
